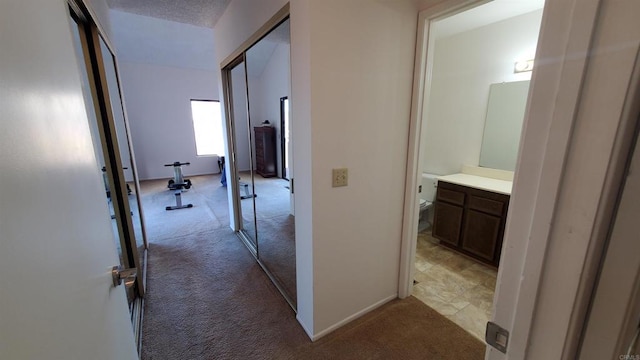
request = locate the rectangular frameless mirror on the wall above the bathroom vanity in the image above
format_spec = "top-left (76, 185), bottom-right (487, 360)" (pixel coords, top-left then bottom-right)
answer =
top-left (480, 80), bottom-right (529, 171)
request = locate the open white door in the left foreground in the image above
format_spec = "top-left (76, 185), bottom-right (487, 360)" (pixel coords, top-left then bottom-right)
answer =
top-left (0, 0), bottom-right (137, 359)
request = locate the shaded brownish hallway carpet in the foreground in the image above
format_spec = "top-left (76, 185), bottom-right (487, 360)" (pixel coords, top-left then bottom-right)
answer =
top-left (142, 222), bottom-right (484, 360)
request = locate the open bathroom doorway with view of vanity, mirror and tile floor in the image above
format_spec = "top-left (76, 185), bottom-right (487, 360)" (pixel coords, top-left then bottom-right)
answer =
top-left (410, 1), bottom-right (544, 340)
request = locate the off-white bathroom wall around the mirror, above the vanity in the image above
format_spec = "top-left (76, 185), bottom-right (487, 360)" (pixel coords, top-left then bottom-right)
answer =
top-left (423, 10), bottom-right (542, 175)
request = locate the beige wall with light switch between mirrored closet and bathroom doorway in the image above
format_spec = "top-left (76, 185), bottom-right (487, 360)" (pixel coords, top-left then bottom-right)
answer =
top-left (215, 0), bottom-right (417, 338)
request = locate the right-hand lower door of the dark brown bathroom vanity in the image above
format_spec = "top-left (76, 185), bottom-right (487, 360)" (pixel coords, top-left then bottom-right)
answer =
top-left (462, 209), bottom-right (502, 263)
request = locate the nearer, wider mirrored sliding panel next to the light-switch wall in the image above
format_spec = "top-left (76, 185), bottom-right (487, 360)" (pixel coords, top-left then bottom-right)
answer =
top-left (245, 19), bottom-right (296, 308)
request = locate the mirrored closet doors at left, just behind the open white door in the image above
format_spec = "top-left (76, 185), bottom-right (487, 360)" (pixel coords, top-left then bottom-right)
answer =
top-left (69, 3), bottom-right (146, 308)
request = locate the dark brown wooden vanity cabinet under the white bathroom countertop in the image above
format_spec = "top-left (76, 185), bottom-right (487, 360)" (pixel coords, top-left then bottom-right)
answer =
top-left (433, 181), bottom-right (509, 266)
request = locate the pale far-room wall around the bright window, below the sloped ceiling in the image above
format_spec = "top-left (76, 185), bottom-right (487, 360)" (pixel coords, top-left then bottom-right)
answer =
top-left (120, 62), bottom-right (218, 180)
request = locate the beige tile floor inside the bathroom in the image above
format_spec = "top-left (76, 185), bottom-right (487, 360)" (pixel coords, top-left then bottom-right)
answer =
top-left (413, 231), bottom-right (497, 341)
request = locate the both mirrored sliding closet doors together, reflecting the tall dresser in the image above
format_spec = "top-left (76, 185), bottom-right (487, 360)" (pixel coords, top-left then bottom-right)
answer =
top-left (223, 18), bottom-right (297, 309)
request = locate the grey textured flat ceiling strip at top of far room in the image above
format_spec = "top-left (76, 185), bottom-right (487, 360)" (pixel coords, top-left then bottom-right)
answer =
top-left (107, 0), bottom-right (231, 28)
